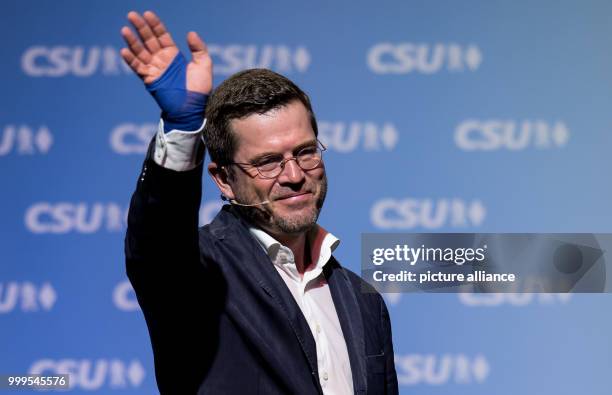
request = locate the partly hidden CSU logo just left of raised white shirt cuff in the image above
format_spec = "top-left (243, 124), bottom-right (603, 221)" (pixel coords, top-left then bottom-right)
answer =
top-left (110, 123), bottom-right (159, 155)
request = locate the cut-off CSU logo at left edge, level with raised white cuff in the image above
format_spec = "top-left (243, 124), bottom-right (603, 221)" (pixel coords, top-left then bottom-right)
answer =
top-left (0, 125), bottom-right (53, 156)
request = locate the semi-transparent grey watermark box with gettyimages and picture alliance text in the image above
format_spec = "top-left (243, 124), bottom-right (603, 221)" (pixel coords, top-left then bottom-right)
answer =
top-left (361, 233), bottom-right (612, 293)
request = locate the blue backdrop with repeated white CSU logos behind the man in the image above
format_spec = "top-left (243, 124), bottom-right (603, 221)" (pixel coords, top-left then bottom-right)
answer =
top-left (0, 0), bottom-right (612, 395)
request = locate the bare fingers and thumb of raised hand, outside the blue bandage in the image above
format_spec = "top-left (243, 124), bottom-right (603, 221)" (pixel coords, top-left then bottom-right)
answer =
top-left (121, 11), bottom-right (212, 94)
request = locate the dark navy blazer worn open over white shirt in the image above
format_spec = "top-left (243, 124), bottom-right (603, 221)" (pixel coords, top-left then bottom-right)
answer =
top-left (125, 156), bottom-right (398, 395)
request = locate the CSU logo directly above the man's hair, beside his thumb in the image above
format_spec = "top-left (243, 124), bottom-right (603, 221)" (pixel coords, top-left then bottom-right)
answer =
top-left (208, 44), bottom-right (310, 75)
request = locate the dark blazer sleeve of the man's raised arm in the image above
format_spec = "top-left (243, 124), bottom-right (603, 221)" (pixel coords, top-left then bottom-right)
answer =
top-left (125, 144), bottom-right (206, 394)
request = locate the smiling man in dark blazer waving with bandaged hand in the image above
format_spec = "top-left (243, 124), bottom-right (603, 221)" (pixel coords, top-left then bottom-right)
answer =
top-left (121, 12), bottom-right (398, 395)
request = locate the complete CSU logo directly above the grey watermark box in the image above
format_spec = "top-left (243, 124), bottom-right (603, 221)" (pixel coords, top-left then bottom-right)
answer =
top-left (370, 198), bottom-right (486, 229)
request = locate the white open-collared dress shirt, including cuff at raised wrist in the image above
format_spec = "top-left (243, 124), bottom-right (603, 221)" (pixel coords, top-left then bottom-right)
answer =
top-left (153, 120), bottom-right (354, 395)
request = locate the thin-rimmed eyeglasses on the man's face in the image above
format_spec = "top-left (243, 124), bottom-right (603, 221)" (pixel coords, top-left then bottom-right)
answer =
top-left (228, 140), bottom-right (327, 178)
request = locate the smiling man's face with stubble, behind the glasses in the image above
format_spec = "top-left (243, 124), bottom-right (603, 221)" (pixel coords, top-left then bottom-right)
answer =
top-left (229, 101), bottom-right (327, 240)
